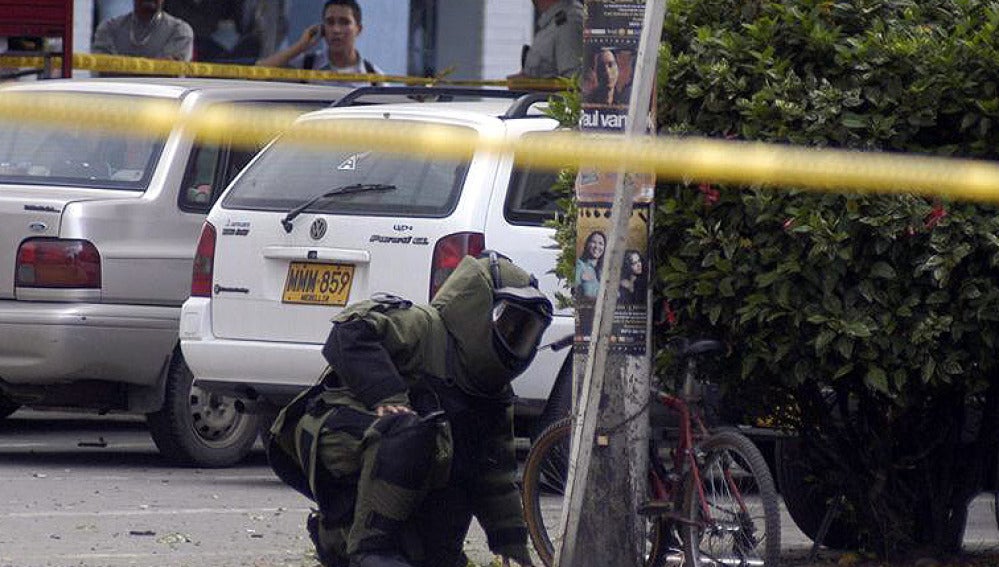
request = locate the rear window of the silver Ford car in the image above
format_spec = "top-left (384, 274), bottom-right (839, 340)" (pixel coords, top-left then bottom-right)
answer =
top-left (0, 110), bottom-right (163, 191)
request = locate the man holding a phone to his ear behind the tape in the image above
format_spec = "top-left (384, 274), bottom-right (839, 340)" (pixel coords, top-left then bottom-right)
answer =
top-left (257, 0), bottom-right (384, 86)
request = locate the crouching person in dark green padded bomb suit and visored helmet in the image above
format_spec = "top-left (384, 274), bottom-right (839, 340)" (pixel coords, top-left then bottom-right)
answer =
top-left (268, 252), bottom-right (552, 567)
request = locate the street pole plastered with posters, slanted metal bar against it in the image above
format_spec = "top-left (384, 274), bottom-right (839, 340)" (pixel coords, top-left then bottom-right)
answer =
top-left (555, 0), bottom-right (667, 565)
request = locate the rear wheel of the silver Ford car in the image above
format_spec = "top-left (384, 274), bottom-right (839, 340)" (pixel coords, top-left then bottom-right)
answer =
top-left (146, 349), bottom-right (260, 468)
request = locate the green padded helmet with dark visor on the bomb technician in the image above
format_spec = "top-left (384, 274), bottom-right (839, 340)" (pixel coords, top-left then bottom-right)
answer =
top-left (431, 251), bottom-right (552, 396)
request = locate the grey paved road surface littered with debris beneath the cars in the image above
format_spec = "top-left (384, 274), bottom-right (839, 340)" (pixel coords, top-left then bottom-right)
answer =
top-left (0, 411), bottom-right (999, 567)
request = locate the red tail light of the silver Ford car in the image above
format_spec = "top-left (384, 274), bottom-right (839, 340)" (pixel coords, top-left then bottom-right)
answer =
top-left (14, 238), bottom-right (101, 289)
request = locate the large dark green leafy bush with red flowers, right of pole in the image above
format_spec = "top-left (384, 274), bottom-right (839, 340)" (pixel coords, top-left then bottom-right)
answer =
top-left (654, 0), bottom-right (999, 556)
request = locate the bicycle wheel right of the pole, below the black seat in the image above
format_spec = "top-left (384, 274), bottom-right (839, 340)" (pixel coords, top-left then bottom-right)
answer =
top-left (681, 431), bottom-right (780, 566)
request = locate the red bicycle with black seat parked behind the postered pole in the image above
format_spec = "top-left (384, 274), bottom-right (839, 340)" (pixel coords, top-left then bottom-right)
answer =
top-left (522, 340), bottom-right (780, 566)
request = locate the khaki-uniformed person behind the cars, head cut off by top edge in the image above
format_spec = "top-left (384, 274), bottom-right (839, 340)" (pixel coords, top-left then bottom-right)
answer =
top-left (508, 0), bottom-right (583, 79)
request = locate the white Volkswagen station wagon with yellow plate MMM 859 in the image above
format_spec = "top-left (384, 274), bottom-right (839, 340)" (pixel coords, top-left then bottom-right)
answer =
top-left (180, 87), bottom-right (573, 452)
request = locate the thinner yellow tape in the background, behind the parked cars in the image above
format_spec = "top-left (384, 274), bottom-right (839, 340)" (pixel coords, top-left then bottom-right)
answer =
top-left (0, 53), bottom-right (566, 90)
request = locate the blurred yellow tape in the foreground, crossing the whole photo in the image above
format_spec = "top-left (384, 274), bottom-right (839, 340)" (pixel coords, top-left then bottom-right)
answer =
top-left (0, 90), bottom-right (999, 203)
